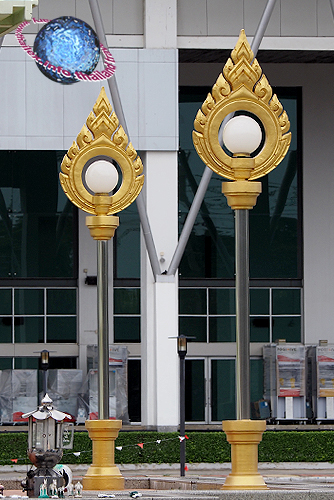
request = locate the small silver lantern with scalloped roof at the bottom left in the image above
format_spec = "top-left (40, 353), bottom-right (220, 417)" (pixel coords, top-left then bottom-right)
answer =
top-left (22, 394), bottom-right (73, 497)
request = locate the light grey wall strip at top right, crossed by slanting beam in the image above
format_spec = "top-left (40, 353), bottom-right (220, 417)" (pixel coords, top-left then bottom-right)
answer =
top-left (178, 0), bottom-right (334, 37)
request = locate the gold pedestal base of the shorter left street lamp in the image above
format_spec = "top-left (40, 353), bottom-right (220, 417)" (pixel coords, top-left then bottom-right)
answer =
top-left (82, 420), bottom-right (124, 490)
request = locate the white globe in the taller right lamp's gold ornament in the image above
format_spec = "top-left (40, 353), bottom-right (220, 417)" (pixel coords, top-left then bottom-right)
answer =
top-left (223, 115), bottom-right (262, 155)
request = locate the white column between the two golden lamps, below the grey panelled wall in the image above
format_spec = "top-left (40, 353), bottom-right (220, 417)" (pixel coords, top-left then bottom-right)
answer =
top-left (141, 151), bottom-right (179, 430)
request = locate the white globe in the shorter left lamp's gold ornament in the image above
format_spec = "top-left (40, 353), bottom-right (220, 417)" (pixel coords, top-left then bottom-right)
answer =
top-left (85, 160), bottom-right (118, 193)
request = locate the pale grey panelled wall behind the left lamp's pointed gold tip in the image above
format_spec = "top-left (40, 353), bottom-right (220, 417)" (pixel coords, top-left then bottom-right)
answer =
top-left (0, 46), bottom-right (178, 151)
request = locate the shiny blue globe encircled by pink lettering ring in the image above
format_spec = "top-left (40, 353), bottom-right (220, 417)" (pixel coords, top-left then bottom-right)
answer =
top-left (33, 16), bottom-right (100, 85)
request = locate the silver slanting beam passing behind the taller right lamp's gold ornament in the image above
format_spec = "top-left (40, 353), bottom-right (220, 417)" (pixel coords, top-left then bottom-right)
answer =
top-left (167, 0), bottom-right (278, 275)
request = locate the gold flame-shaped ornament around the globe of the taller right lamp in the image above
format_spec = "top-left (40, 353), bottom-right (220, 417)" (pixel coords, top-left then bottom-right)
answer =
top-left (193, 30), bottom-right (291, 191)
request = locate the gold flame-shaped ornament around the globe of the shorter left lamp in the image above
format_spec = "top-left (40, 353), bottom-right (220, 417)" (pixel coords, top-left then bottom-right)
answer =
top-left (59, 87), bottom-right (144, 239)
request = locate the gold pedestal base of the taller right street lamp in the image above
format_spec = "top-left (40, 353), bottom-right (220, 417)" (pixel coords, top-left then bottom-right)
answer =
top-left (222, 420), bottom-right (268, 490)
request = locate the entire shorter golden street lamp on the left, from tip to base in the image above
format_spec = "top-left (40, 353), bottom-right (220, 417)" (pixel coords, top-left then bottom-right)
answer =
top-left (59, 87), bottom-right (144, 490)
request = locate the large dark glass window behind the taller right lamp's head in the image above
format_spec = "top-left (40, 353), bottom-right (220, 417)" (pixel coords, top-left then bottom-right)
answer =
top-left (179, 87), bottom-right (302, 279)
